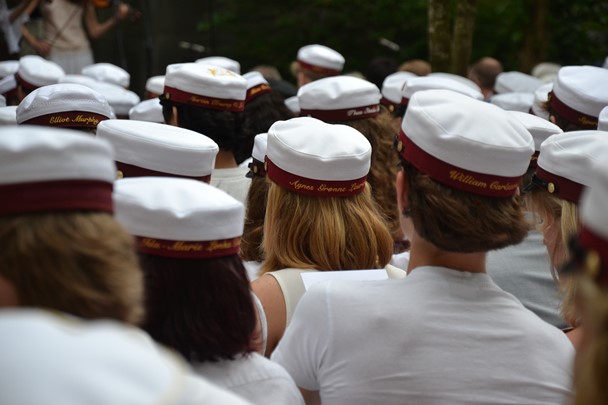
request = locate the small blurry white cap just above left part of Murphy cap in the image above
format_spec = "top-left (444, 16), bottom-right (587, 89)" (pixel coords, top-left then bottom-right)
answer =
top-left (15, 55), bottom-right (65, 92)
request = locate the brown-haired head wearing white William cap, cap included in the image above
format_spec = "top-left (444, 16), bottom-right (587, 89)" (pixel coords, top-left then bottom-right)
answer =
top-left (397, 90), bottom-right (534, 253)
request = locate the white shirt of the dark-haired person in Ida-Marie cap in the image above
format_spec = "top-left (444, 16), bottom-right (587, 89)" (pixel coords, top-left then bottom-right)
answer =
top-left (193, 353), bottom-right (304, 405)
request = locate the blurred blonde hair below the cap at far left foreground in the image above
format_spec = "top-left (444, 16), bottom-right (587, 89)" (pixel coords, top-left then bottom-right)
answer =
top-left (0, 212), bottom-right (143, 324)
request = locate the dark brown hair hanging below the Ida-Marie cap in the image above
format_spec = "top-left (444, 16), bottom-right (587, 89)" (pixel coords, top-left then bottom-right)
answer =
top-left (140, 254), bottom-right (257, 362)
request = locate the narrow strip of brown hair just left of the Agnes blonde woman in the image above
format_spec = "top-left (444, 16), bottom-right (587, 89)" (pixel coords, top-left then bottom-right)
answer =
top-left (241, 175), bottom-right (268, 262)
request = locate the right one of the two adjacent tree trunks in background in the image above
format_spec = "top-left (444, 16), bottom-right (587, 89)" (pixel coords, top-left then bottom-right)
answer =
top-left (450, 0), bottom-right (477, 77)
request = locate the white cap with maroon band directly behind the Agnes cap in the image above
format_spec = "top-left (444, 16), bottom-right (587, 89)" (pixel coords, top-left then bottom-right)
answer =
top-left (298, 76), bottom-right (382, 122)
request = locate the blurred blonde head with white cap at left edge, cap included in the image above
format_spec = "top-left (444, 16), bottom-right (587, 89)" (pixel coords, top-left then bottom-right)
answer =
top-left (0, 125), bottom-right (143, 323)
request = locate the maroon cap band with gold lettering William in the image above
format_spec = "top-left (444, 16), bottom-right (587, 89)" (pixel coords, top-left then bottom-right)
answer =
top-left (397, 131), bottom-right (521, 197)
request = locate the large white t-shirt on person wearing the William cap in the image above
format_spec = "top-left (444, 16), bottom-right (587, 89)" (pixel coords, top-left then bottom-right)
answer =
top-left (272, 267), bottom-right (574, 405)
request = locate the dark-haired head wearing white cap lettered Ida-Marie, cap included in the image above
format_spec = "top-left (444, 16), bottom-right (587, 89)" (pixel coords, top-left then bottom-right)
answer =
top-left (114, 177), bottom-right (256, 362)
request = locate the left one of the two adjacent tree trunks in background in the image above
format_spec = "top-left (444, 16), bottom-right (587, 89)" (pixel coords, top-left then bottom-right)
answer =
top-left (428, 0), bottom-right (451, 72)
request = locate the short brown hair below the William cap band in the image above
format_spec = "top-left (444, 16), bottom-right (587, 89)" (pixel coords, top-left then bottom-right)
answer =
top-left (402, 160), bottom-right (529, 253)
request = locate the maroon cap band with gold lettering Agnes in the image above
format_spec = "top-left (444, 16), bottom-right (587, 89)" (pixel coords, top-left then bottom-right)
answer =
top-left (266, 157), bottom-right (367, 197)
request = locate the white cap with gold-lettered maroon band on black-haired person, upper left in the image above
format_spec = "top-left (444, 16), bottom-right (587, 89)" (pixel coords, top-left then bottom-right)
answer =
top-left (164, 63), bottom-right (247, 112)
